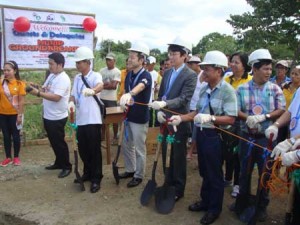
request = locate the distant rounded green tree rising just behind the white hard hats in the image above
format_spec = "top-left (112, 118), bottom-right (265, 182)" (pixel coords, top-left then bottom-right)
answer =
top-left (193, 32), bottom-right (238, 55)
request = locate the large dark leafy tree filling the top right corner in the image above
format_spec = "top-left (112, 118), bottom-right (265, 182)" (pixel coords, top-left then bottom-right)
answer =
top-left (227, 0), bottom-right (300, 63)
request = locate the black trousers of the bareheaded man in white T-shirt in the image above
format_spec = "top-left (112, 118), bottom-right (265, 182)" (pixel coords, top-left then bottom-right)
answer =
top-left (44, 117), bottom-right (72, 169)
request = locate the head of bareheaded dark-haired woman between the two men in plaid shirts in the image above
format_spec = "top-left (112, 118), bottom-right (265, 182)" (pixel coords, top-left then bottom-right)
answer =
top-left (229, 52), bottom-right (251, 79)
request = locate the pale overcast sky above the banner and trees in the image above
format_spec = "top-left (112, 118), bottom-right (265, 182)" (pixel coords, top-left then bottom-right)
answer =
top-left (1, 0), bottom-right (252, 51)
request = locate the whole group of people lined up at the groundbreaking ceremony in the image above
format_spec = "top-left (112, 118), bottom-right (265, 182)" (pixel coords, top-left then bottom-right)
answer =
top-left (0, 37), bottom-right (300, 224)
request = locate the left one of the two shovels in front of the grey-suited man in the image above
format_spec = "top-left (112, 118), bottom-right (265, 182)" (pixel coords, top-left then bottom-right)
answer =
top-left (140, 134), bottom-right (161, 206)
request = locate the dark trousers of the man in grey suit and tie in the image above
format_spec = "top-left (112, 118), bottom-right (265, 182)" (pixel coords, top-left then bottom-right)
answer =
top-left (162, 130), bottom-right (188, 197)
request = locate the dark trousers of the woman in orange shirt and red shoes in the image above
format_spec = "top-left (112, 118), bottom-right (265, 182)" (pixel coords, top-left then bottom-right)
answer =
top-left (0, 115), bottom-right (21, 158)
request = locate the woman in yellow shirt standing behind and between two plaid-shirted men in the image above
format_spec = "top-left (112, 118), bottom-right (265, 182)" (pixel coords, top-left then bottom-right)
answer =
top-left (224, 52), bottom-right (252, 197)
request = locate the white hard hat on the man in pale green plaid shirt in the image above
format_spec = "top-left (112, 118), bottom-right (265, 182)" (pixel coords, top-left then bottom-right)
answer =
top-left (199, 50), bottom-right (228, 68)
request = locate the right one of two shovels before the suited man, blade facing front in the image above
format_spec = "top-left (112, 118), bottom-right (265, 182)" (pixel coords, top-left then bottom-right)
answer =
top-left (155, 134), bottom-right (175, 214)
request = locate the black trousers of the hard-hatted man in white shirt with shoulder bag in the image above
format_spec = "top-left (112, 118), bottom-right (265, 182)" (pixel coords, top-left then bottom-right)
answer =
top-left (77, 124), bottom-right (103, 184)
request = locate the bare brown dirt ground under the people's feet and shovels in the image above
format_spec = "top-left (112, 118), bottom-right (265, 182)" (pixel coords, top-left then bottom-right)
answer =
top-left (0, 142), bottom-right (286, 225)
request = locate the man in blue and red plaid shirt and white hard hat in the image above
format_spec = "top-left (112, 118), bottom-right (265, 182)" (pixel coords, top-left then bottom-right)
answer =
top-left (235, 49), bottom-right (285, 221)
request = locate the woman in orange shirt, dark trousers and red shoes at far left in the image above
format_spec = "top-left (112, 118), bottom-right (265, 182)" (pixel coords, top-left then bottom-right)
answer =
top-left (0, 61), bottom-right (26, 166)
